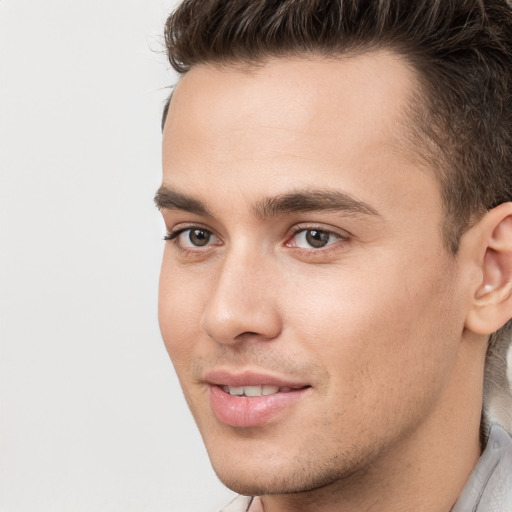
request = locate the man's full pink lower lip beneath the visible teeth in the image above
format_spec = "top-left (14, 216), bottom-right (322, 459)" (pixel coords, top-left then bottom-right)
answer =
top-left (210, 386), bottom-right (310, 427)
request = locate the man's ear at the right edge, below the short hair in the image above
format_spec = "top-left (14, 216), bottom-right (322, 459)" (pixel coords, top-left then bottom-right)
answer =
top-left (465, 203), bottom-right (512, 334)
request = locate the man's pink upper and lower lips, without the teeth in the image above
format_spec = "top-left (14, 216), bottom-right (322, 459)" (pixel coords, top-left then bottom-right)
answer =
top-left (205, 371), bottom-right (311, 428)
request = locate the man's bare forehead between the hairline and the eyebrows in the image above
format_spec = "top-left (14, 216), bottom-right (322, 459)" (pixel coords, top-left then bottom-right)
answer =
top-left (163, 51), bottom-right (438, 221)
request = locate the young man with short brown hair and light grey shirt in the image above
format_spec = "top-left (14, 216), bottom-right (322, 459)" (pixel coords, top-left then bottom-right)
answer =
top-left (156, 0), bottom-right (512, 512)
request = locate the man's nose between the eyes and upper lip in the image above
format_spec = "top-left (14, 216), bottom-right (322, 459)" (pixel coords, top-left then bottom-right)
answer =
top-left (201, 248), bottom-right (282, 345)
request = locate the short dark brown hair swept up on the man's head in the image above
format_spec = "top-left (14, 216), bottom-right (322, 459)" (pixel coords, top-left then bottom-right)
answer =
top-left (164, 0), bottom-right (512, 432)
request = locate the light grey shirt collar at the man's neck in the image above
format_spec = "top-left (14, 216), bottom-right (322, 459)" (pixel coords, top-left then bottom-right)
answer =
top-left (220, 424), bottom-right (512, 512)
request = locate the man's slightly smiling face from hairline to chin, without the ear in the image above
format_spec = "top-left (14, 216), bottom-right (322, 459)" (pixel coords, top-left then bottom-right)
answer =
top-left (158, 53), bottom-right (470, 494)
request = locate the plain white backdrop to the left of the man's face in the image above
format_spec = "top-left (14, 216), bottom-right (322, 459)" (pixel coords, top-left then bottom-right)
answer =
top-left (0, 0), bottom-right (235, 512)
